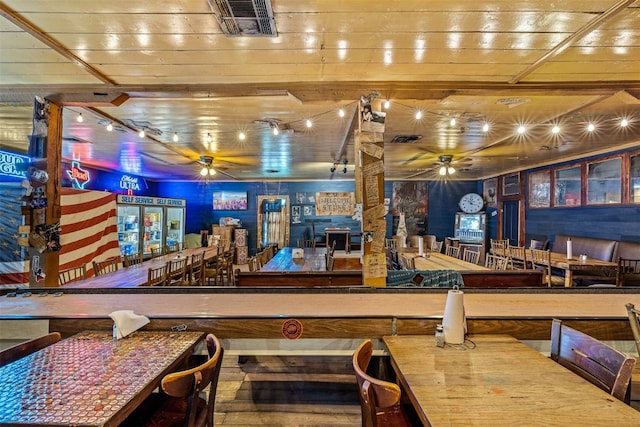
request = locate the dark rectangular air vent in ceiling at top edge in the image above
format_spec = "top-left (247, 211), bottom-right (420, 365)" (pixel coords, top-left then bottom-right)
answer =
top-left (209, 0), bottom-right (278, 37)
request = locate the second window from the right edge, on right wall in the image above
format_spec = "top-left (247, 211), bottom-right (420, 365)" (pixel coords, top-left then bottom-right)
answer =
top-left (587, 157), bottom-right (622, 205)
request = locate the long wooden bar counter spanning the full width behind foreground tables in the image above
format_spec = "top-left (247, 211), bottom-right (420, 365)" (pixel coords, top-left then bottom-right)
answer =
top-left (0, 288), bottom-right (640, 340)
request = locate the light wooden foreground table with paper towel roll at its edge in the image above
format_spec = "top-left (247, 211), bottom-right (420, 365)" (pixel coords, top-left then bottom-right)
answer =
top-left (383, 335), bottom-right (640, 426)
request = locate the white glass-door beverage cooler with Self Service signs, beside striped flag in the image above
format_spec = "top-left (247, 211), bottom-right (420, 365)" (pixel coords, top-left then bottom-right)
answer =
top-left (117, 194), bottom-right (186, 257)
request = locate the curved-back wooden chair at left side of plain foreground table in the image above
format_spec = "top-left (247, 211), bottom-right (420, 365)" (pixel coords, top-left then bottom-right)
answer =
top-left (353, 340), bottom-right (412, 427)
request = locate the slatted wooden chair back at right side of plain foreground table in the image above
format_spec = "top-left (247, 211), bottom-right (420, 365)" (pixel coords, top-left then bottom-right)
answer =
top-left (551, 319), bottom-right (635, 402)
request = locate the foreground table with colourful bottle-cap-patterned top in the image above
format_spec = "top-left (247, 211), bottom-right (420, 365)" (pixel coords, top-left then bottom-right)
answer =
top-left (0, 331), bottom-right (204, 426)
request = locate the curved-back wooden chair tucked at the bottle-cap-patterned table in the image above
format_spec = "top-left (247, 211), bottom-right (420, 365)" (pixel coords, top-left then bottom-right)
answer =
top-left (121, 334), bottom-right (224, 427)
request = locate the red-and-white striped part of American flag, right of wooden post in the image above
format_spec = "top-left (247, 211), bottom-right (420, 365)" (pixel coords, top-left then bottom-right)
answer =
top-left (59, 187), bottom-right (120, 276)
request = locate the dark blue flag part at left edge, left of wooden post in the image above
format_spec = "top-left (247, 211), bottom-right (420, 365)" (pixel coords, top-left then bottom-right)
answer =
top-left (0, 182), bottom-right (29, 286)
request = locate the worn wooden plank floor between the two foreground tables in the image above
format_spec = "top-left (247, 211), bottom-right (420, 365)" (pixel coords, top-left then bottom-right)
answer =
top-left (215, 355), bottom-right (361, 427)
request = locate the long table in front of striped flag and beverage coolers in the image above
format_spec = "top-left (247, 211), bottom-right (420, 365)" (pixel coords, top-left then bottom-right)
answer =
top-left (64, 247), bottom-right (218, 288)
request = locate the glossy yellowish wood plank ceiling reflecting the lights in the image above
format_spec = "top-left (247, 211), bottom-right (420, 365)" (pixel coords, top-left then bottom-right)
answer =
top-left (0, 0), bottom-right (640, 180)
